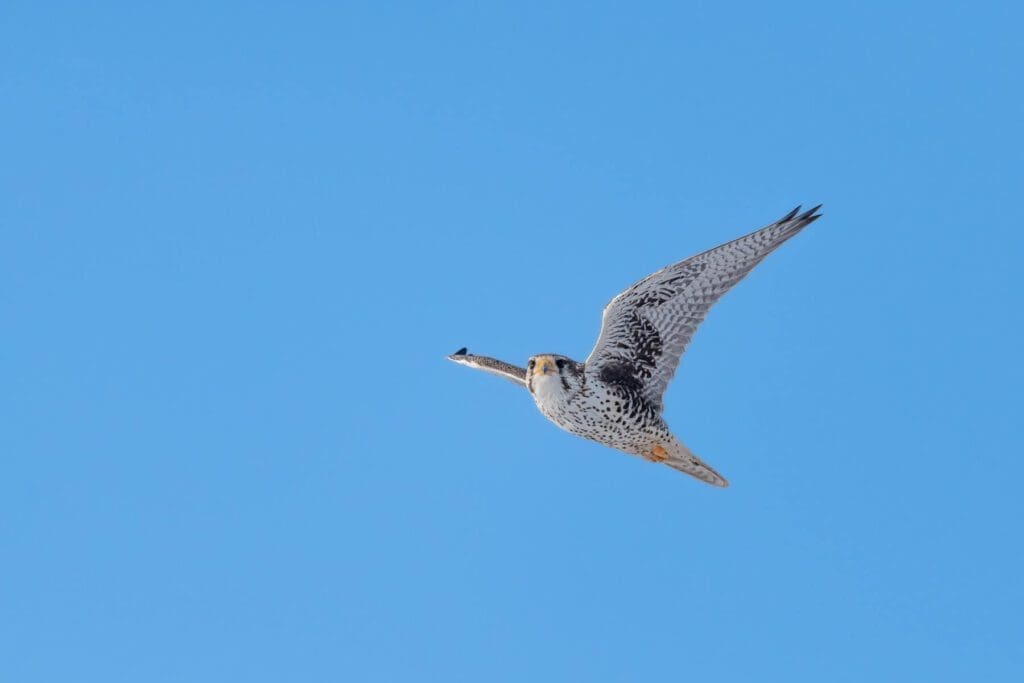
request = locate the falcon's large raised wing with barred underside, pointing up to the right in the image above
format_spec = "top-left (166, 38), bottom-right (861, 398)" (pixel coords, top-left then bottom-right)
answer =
top-left (587, 207), bottom-right (820, 411)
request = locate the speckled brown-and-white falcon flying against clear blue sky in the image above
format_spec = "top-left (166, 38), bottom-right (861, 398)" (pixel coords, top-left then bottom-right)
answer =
top-left (447, 205), bottom-right (821, 487)
